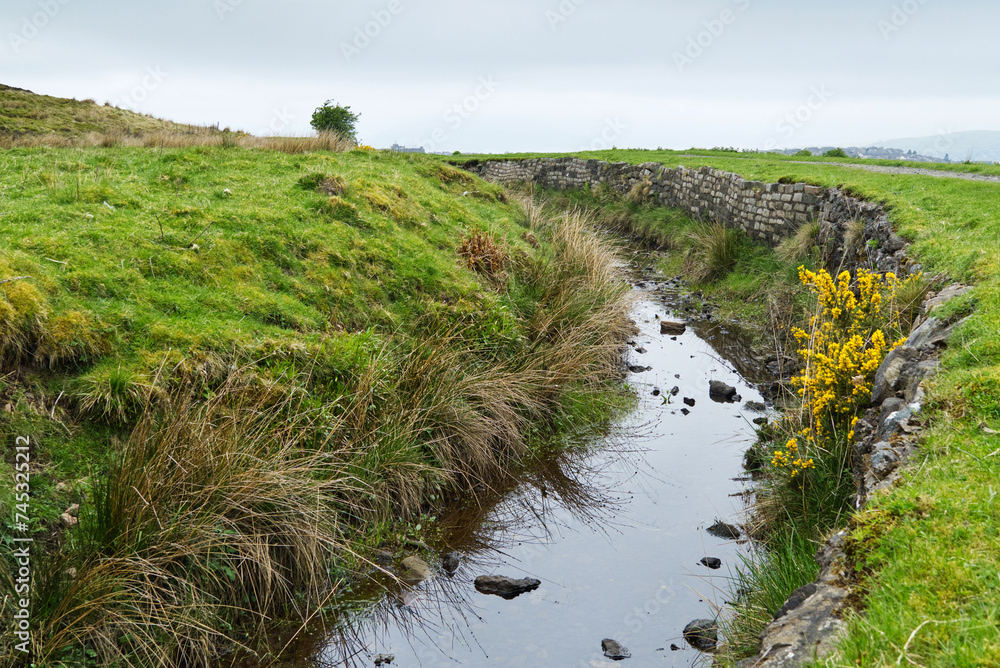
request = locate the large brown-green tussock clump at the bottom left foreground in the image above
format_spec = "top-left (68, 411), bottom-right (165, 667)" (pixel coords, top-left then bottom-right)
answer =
top-left (36, 374), bottom-right (361, 666)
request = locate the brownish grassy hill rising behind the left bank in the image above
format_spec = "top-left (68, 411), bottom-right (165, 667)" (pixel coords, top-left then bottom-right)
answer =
top-left (0, 84), bottom-right (217, 137)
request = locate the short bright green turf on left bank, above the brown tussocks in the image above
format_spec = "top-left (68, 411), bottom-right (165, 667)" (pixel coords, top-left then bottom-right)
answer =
top-left (0, 148), bottom-right (529, 520)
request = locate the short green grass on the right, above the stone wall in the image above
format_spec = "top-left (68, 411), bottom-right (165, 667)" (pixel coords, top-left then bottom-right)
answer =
top-left (462, 151), bottom-right (1000, 666)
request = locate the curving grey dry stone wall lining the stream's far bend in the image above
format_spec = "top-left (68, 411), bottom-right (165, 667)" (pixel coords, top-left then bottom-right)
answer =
top-left (464, 157), bottom-right (917, 275)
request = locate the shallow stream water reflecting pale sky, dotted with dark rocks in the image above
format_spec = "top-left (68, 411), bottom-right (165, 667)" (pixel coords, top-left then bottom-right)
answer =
top-left (262, 254), bottom-right (768, 668)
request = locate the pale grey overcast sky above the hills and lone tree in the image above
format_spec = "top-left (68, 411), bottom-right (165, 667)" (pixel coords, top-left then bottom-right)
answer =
top-left (0, 0), bottom-right (1000, 152)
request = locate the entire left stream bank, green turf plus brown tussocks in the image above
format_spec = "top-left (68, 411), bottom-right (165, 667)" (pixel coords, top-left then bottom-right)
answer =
top-left (0, 145), bottom-right (631, 666)
